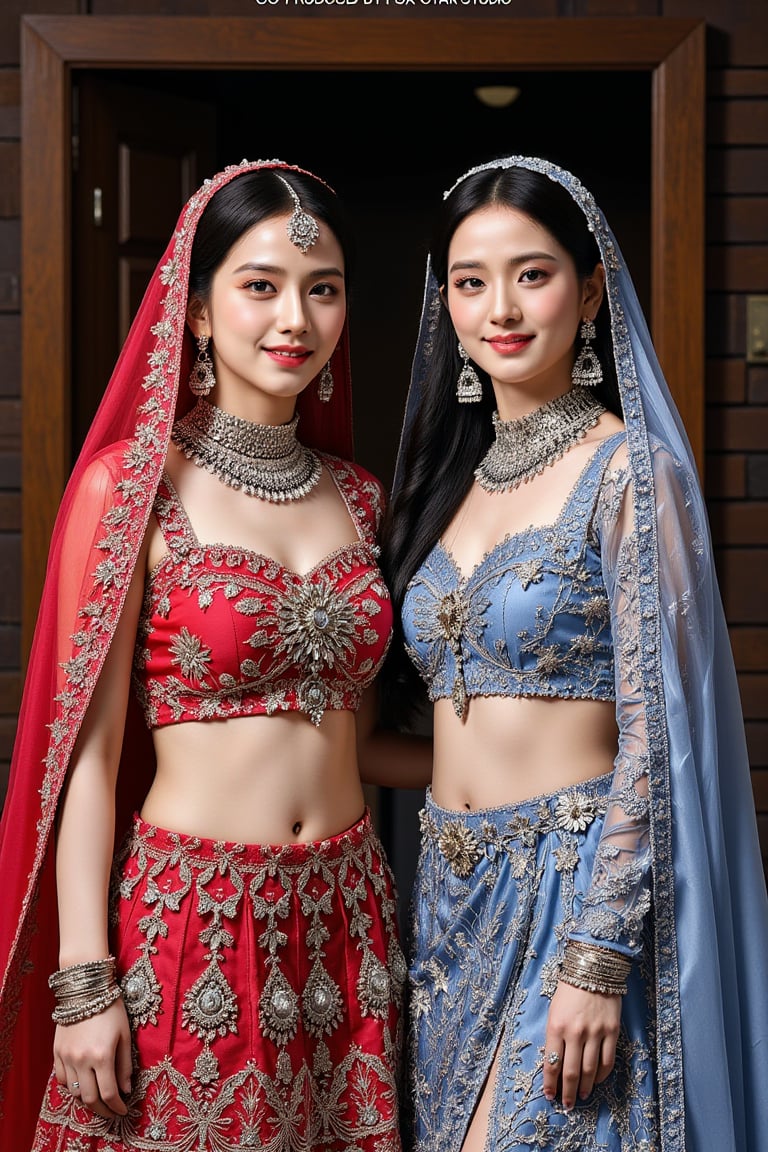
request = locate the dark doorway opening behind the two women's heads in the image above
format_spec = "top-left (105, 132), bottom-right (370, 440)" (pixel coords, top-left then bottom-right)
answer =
top-left (73, 69), bottom-right (652, 484)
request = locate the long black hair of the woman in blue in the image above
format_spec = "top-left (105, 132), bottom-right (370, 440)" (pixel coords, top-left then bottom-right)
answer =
top-left (381, 168), bottom-right (621, 723)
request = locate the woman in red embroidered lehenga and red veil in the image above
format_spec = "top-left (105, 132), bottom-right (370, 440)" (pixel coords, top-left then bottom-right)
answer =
top-left (0, 160), bottom-right (404, 1152)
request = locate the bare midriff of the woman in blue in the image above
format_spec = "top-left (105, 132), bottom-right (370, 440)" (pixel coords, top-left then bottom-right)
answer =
top-left (432, 696), bottom-right (617, 811)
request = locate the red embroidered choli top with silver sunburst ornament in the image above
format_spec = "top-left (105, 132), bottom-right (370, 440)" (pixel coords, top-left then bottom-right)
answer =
top-left (134, 456), bottom-right (391, 728)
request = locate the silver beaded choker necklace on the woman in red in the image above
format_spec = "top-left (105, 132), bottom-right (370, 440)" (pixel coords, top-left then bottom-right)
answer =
top-left (170, 400), bottom-right (321, 503)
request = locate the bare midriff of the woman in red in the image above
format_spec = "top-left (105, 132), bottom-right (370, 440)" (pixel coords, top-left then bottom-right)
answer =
top-left (142, 710), bottom-right (365, 844)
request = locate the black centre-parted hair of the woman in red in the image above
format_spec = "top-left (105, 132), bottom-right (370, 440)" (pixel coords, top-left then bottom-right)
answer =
top-left (189, 168), bottom-right (355, 303)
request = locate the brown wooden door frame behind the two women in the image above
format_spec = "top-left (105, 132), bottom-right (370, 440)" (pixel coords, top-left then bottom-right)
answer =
top-left (22, 15), bottom-right (706, 659)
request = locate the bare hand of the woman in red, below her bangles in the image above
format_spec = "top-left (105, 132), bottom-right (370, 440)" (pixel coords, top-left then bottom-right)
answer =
top-left (53, 999), bottom-right (131, 1120)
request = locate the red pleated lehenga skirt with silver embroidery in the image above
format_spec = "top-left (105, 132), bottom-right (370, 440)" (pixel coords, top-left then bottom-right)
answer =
top-left (31, 814), bottom-right (405, 1152)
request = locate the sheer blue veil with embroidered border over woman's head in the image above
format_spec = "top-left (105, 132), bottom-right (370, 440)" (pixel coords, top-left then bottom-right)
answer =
top-left (394, 156), bottom-right (768, 1152)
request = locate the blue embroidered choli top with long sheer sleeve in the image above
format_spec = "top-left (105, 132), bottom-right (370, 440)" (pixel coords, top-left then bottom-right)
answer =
top-left (403, 433), bottom-right (651, 955)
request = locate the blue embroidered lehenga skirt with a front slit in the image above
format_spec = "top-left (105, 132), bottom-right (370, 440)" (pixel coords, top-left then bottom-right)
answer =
top-left (404, 774), bottom-right (660, 1152)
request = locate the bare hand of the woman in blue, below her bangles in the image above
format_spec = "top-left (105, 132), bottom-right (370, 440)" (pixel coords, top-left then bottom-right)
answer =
top-left (543, 982), bottom-right (622, 1112)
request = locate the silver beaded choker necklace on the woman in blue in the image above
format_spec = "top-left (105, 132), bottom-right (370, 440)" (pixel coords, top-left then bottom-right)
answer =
top-left (474, 388), bottom-right (606, 492)
